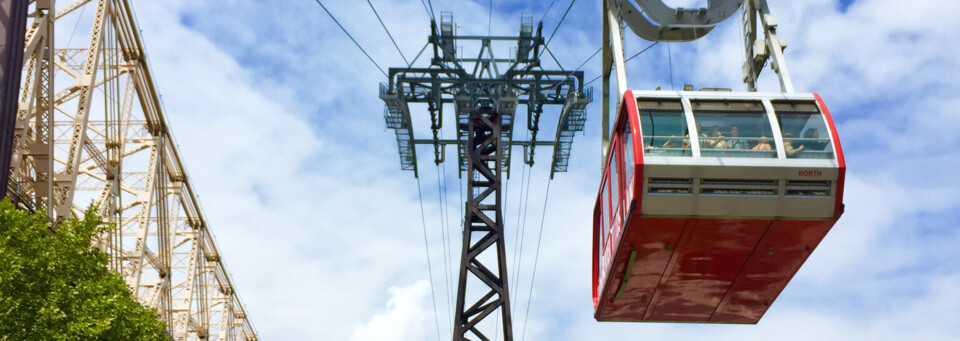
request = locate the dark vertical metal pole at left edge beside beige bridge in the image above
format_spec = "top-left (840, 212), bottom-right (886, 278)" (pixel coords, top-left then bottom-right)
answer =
top-left (0, 0), bottom-right (27, 198)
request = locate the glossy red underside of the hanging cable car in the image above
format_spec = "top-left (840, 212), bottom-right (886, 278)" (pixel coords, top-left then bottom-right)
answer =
top-left (596, 218), bottom-right (836, 323)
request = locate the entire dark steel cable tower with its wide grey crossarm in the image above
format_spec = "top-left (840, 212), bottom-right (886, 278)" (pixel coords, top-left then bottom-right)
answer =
top-left (380, 13), bottom-right (592, 340)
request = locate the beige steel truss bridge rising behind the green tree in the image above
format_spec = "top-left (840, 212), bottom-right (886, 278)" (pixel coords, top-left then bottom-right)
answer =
top-left (0, 0), bottom-right (257, 340)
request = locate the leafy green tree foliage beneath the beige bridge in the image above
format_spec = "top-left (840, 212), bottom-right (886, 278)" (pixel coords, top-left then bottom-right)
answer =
top-left (0, 199), bottom-right (166, 340)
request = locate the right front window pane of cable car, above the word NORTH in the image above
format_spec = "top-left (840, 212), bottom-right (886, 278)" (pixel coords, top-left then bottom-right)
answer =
top-left (773, 101), bottom-right (834, 159)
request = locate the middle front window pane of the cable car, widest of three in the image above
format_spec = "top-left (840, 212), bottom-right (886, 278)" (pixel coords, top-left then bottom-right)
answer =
top-left (691, 101), bottom-right (777, 158)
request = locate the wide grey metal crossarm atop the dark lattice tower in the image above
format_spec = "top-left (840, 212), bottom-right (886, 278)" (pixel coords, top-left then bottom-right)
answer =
top-left (380, 65), bottom-right (592, 173)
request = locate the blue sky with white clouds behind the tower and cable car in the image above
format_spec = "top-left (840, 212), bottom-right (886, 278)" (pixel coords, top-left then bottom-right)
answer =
top-left (122, 0), bottom-right (960, 341)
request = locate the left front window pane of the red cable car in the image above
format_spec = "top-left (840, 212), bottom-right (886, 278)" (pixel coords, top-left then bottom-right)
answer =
top-left (637, 100), bottom-right (693, 156)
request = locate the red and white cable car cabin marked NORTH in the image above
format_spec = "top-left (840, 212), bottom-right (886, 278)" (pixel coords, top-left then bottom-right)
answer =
top-left (593, 91), bottom-right (845, 323)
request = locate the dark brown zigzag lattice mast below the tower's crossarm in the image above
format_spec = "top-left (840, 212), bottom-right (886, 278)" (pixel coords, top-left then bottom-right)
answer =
top-left (453, 107), bottom-right (513, 341)
